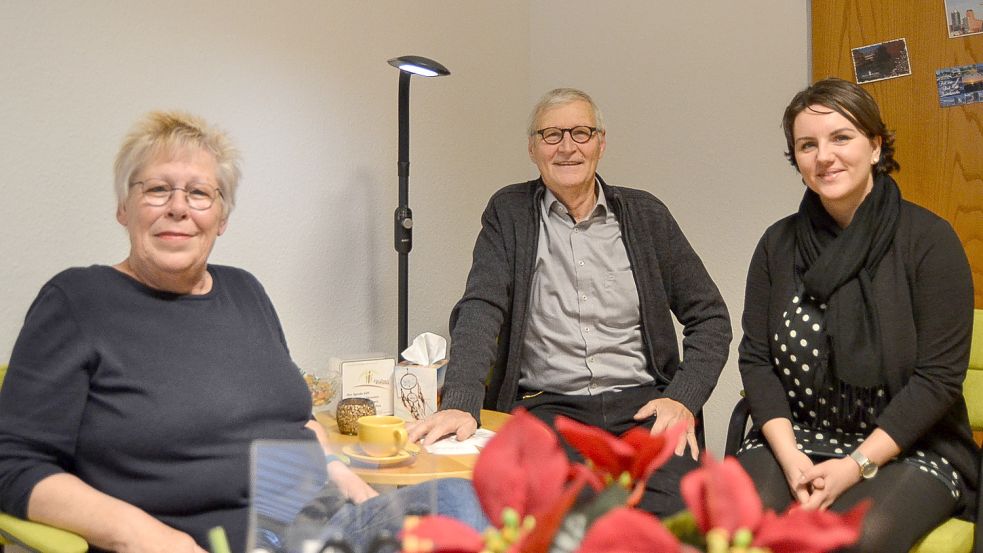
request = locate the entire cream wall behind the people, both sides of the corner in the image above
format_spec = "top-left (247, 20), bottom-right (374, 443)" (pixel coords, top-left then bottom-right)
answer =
top-left (0, 0), bottom-right (808, 449)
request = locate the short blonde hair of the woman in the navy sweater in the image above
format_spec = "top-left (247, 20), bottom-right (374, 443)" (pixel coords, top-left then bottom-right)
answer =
top-left (115, 111), bottom-right (242, 217)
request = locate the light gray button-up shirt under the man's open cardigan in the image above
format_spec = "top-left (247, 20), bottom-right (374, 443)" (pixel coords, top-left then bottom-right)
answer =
top-left (519, 184), bottom-right (654, 395)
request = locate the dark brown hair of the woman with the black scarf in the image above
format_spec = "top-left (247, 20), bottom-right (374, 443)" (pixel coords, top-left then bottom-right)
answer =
top-left (782, 77), bottom-right (901, 174)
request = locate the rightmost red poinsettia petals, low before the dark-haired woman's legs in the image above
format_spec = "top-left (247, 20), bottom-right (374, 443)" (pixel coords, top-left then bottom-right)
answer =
top-left (752, 501), bottom-right (870, 553)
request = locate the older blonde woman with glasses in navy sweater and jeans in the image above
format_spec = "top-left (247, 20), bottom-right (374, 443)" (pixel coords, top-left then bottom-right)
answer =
top-left (0, 113), bottom-right (483, 553)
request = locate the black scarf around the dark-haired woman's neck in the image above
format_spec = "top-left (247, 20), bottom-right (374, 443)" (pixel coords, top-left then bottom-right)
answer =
top-left (795, 174), bottom-right (901, 396)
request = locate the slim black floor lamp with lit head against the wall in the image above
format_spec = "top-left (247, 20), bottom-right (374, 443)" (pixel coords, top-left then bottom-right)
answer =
top-left (389, 56), bottom-right (451, 356)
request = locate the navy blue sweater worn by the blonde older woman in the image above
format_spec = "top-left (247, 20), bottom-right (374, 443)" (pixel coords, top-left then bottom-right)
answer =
top-left (0, 265), bottom-right (313, 551)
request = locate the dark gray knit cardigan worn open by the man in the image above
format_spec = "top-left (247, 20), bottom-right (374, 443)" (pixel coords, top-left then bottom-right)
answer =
top-left (441, 176), bottom-right (731, 420)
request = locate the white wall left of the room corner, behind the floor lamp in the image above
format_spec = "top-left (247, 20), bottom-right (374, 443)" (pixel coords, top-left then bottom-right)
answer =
top-left (0, 0), bottom-right (529, 369)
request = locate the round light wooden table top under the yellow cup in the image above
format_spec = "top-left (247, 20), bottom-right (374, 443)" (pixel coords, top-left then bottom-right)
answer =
top-left (315, 409), bottom-right (509, 486)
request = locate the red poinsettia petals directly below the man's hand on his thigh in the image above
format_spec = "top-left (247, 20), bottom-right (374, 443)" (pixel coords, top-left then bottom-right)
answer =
top-left (556, 416), bottom-right (686, 505)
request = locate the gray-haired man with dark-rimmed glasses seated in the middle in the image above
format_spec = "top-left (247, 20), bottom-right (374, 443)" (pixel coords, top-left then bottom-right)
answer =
top-left (410, 88), bottom-right (731, 516)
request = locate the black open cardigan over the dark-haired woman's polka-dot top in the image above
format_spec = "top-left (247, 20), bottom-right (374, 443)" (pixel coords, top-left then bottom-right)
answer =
top-left (739, 201), bottom-right (980, 513)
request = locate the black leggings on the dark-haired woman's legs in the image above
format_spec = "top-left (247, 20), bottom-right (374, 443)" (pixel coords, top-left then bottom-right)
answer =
top-left (737, 447), bottom-right (958, 553)
